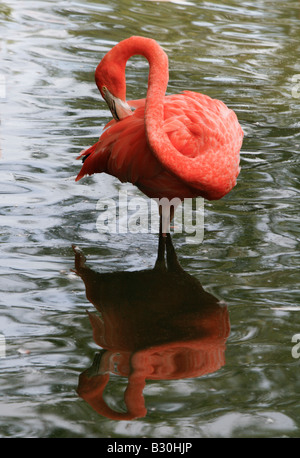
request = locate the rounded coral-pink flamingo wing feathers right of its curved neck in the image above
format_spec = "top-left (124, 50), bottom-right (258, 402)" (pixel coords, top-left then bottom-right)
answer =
top-left (153, 91), bottom-right (243, 200)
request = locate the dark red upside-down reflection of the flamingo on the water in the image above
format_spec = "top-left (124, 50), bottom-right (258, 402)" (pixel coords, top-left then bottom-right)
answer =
top-left (73, 238), bottom-right (230, 420)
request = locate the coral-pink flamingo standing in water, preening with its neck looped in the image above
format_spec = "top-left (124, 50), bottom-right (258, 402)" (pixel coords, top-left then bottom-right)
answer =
top-left (76, 36), bottom-right (243, 236)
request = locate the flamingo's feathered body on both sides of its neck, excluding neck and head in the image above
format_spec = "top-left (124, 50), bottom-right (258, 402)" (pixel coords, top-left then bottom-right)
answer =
top-left (76, 91), bottom-right (241, 199)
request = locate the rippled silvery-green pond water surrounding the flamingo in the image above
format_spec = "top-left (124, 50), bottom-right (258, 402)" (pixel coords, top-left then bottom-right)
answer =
top-left (0, 0), bottom-right (300, 438)
